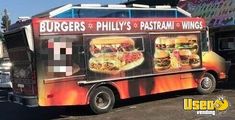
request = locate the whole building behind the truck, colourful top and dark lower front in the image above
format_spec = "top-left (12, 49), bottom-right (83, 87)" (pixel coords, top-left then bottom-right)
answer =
top-left (178, 0), bottom-right (235, 63)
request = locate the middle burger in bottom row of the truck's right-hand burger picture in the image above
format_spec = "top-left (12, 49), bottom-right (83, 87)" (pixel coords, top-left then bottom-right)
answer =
top-left (179, 49), bottom-right (192, 68)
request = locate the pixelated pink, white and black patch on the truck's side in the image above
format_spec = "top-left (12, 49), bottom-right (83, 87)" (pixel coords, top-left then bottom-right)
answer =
top-left (47, 37), bottom-right (80, 76)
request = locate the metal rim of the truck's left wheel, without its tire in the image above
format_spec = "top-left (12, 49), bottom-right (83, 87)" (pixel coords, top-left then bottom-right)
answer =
top-left (95, 92), bottom-right (111, 109)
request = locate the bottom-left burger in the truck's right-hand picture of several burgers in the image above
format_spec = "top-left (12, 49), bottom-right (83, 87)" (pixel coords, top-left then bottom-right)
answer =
top-left (154, 50), bottom-right (171, 71)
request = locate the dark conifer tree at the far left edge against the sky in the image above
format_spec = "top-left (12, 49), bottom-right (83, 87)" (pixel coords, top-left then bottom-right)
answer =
top-left (1, 9), bottom-right (11, 32)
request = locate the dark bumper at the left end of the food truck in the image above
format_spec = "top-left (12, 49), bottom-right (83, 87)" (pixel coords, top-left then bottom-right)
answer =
top-left (8, 92), bottom-right (38, 107)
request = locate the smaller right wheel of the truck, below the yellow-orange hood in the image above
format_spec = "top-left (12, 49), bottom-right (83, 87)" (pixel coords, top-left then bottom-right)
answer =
top-left (197, 73), bottom-right (216, 94)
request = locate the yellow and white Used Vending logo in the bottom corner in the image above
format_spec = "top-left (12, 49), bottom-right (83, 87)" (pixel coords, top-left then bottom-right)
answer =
top-left (184, 96), bottom-right (230, 115)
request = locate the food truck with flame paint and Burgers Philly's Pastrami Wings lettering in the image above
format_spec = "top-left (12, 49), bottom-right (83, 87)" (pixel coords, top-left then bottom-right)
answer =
top-left (5, 5), bottom-right (227, 114)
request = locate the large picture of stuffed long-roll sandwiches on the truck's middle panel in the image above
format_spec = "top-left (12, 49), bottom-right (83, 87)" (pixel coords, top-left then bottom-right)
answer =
top-left (89, 36), bottom-right (144, 74)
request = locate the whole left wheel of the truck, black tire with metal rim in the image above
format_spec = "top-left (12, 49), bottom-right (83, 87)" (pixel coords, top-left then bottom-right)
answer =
top-left (89, 86), bottom-right (115, 114)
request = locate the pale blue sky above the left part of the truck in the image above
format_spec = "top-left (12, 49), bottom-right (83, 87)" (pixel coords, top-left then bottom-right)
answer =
top-left (0, 0), bottom-right (127, 23)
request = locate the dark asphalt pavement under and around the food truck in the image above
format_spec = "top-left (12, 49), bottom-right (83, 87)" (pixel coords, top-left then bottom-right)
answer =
top-left (0, 67), bottom-right (235, 120)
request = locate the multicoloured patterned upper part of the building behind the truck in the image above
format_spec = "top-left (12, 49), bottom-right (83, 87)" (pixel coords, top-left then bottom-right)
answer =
top-left (179, 0), bottom-right (235, 28)
